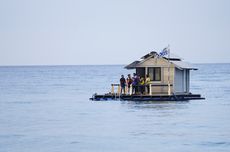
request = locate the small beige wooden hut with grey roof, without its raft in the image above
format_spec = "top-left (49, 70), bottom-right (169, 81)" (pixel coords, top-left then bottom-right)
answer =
top-left (125, 52), bottom-right (197, 94)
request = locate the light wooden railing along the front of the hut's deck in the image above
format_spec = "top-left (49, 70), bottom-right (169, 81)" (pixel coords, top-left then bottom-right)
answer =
top-left (111, 84), bottom-right (173, 95)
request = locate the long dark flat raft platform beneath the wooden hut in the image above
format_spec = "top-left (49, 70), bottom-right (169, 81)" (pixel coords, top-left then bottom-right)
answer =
top-left (90, 94), bottom-right (205, 101)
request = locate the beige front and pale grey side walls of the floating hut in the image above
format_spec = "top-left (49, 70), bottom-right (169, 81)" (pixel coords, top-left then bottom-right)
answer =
top-left (129, 58), bottom-right (190, 94)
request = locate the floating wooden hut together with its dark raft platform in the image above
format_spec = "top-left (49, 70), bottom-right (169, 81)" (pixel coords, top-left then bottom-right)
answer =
top-left (90, 51), bottom-right (204, 101)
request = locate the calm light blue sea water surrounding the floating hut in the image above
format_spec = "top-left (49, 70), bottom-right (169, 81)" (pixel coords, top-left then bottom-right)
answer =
top-left (0, 64), bottom-right (230, 152)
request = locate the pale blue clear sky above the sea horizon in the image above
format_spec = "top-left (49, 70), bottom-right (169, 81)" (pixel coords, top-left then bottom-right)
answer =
top-left (0, 0), bottom-right (230, 66)
